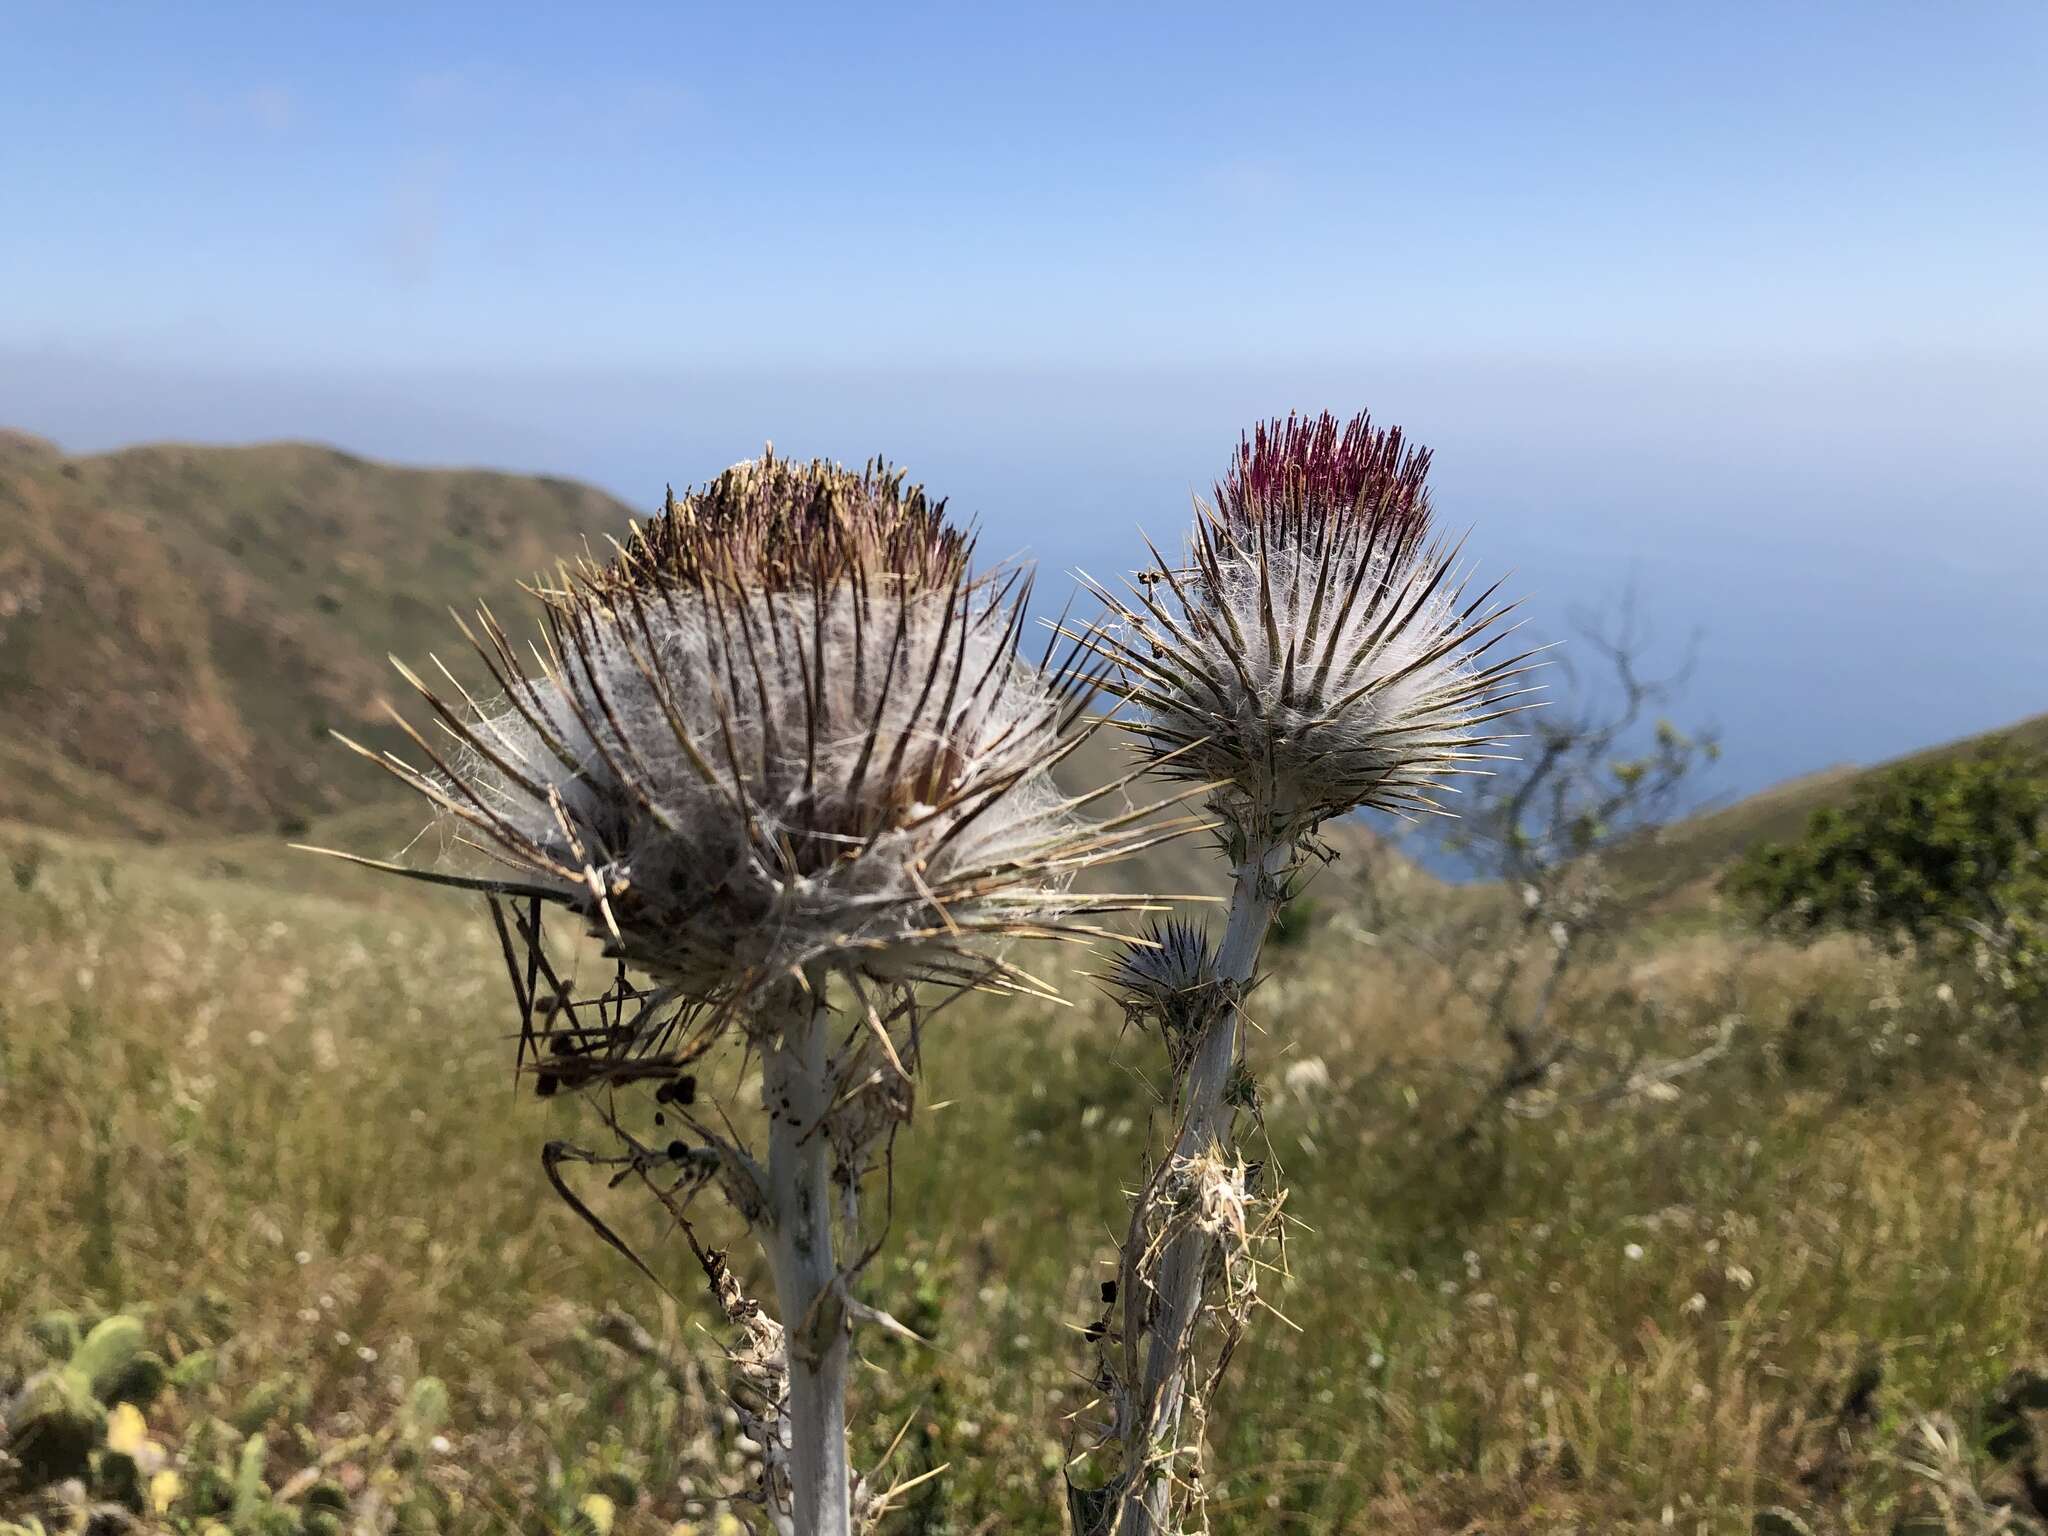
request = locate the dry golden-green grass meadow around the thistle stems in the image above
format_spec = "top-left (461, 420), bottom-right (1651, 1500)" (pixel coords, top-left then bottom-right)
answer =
top-left (0, 794), bottom-right (2048, 1536)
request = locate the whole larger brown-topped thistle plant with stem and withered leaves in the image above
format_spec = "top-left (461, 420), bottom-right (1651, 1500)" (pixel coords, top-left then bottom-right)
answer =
top-left (311, 453), bottom-right (1178, 1536)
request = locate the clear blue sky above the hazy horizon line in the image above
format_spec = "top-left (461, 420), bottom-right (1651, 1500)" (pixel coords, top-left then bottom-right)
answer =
top-left (0, 0), bottom-right (2048, 367)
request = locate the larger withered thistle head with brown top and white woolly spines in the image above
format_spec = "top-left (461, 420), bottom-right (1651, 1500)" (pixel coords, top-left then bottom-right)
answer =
top-left (319, 453), bottom-right (1187, 1056)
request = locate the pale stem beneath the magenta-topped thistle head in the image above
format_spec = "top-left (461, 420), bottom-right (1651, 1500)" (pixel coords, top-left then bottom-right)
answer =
top-left (1116, 844), bottom-right (1292, 1536)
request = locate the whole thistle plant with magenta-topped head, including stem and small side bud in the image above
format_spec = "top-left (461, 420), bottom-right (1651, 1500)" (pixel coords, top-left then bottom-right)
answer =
top-left (1071, 414), bottom-right (1530, 1536)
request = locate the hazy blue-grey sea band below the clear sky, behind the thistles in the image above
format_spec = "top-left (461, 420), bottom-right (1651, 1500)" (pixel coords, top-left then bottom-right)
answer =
top-left (0, 350), bottom-right (2048, 819)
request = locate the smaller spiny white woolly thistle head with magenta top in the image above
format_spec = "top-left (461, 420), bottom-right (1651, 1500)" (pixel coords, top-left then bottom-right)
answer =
top-left (1096, 414), bottom-right (1532, 848)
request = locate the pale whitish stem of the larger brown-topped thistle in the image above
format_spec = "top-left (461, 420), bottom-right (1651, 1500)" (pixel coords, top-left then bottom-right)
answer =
top-left (762, 993), bottom-right (852, 1536)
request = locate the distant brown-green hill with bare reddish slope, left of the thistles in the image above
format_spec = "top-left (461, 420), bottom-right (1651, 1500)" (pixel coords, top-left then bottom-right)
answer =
top-left (0, 434), bottom-right (631, 836)
